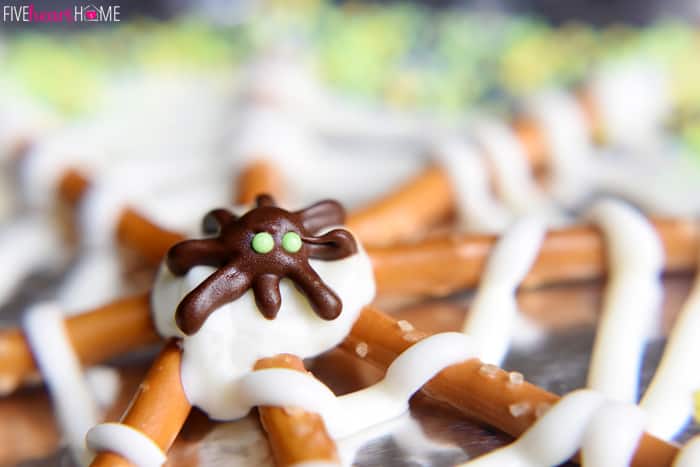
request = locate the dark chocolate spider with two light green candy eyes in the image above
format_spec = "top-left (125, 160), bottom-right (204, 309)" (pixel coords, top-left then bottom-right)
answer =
top-left (166, 195), bottom-right (357, 335)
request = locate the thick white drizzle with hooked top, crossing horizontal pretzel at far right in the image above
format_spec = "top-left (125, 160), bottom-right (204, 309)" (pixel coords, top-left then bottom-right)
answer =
top-left (587, 200), bottom-right (664, 403)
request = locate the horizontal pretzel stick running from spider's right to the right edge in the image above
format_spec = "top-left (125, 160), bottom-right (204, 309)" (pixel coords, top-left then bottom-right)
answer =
top-left (367, 219), bottom-right (700, 295)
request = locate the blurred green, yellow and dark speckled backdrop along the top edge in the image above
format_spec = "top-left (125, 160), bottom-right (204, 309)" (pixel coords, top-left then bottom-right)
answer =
top-left (0, 0), bottom-right (700, 146)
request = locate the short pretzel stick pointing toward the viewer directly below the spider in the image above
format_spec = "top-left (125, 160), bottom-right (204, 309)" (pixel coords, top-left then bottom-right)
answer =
top-left (255, 354), bottom-right (338, 467)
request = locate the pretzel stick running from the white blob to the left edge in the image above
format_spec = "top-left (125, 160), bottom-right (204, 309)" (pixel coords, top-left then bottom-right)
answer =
top-left (0, 294), bottom-right (160, 395)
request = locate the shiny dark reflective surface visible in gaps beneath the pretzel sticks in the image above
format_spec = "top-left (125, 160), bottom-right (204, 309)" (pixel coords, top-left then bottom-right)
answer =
top-left (0, 275), bottom-right (697, 467)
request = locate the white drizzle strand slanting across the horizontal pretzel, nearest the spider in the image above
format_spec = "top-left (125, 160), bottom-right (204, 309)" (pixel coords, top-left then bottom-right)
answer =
top-left (463, 218), bottom-right (546, 365)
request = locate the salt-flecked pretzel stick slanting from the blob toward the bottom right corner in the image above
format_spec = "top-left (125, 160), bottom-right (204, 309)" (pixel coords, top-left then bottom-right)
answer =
top-left (341, 307), bottom-right (678, 467)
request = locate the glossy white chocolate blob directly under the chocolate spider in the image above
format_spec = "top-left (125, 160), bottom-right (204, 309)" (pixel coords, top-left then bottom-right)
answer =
top-left (152, 234), bottom-right (375, 420)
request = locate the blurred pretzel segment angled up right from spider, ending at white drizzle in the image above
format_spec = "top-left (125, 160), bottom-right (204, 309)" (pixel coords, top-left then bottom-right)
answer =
top-left (347, 166), bottom-right (454, 249)
